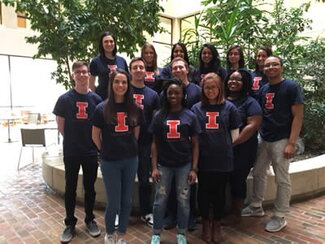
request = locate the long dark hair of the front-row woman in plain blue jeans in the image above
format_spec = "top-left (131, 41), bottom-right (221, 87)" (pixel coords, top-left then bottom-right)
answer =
top-left (103, 69), bottom-right (139, 126)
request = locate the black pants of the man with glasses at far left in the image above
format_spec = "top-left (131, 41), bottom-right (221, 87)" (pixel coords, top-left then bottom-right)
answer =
top-left (63, 155), bottom-right (98, 225)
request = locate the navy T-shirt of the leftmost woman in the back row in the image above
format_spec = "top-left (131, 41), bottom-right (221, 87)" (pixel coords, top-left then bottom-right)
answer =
top-left (89, 55), bottom-right (128, 100)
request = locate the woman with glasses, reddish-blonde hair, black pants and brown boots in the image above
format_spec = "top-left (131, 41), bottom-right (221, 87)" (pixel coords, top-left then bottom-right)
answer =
top-left (192, 73), bottom-right (241, 243)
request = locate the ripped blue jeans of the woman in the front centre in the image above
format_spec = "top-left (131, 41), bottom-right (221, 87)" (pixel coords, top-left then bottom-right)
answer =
top-left (153, 163), bottom-right (192, 235)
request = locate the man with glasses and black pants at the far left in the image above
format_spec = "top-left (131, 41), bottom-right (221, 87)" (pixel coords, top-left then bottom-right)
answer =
top-left (53, 61), bottom-right (102, 242)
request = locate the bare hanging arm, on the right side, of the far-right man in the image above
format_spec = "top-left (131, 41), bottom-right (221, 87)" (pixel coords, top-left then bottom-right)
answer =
top-left (284, 104), bottom-right (304, 159)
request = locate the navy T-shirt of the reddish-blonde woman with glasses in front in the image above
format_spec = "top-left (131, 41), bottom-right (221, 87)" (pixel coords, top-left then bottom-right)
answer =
top-left (192, 101), bottom-right (241, 172)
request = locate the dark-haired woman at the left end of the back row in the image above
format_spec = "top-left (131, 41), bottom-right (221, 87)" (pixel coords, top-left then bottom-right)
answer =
top-left (89, 32), bottom-right (128, 100)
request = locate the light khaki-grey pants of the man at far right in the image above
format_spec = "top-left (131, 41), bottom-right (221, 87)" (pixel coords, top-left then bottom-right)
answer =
top-left (251, 139), bottom-right (291, 217)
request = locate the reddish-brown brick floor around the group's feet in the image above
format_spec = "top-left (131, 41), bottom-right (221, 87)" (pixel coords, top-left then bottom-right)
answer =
top-left (0, 125), bottom-right (325, 244)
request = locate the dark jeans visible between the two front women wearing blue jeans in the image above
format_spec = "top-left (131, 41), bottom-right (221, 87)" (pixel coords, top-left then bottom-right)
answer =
top-left (138, 144), bottom-right (152, 216)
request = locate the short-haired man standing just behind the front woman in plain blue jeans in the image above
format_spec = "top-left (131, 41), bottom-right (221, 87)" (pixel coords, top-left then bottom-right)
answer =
top-left (130, 58), bottom-right (159, 226)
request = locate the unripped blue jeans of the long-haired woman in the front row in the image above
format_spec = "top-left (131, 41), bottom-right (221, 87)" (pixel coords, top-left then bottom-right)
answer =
top-left (100, 157), bottom-right (138, 234)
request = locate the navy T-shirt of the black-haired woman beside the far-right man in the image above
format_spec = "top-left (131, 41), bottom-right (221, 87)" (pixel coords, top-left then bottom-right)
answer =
top-left (229, 96), bottom-right (262, 169)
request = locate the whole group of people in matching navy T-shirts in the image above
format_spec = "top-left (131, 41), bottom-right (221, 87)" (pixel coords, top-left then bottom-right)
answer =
top-left (53, 32), bottom-right (303, 244)
